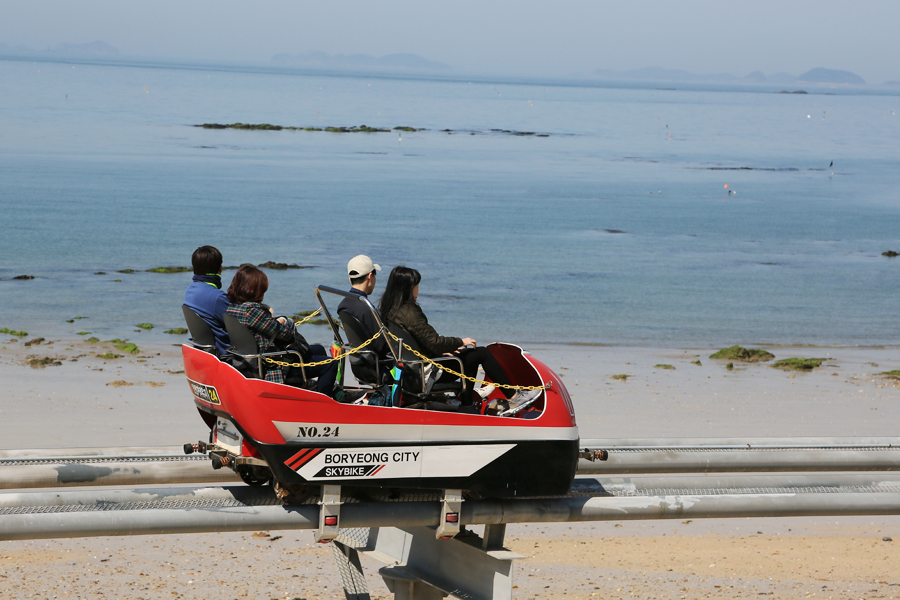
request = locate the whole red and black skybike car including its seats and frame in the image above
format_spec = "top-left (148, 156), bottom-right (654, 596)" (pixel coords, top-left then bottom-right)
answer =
top-left (183, 286), bottom-right (579, 540)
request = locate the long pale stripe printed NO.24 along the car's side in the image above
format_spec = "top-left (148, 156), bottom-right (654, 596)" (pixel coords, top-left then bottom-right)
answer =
top-left (272, 421), bottom-right (578, 444)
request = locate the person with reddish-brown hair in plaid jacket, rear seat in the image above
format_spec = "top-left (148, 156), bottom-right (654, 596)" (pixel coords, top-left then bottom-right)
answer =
top-left (227, 265), bottom-right (338, 396)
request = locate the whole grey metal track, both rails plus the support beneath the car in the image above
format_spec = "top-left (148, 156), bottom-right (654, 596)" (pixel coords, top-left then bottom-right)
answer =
top-left (0, 438), bottom-right (900, 600)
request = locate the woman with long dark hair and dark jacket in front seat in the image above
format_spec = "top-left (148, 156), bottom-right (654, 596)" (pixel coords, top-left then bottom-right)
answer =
top-left (378, 266), bottom-right (540, 407)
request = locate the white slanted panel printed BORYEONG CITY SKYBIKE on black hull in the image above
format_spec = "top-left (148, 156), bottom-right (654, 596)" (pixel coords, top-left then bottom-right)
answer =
top-left (297, 444), bottom-right (515, 481)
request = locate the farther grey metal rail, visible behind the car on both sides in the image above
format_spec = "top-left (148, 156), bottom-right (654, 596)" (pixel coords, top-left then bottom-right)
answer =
top-left (0, 438), bottom-right (900, 489)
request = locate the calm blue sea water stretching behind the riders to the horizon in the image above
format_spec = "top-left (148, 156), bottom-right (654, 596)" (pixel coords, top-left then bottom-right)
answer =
top-left (0, 60), bottom-right (900, 347)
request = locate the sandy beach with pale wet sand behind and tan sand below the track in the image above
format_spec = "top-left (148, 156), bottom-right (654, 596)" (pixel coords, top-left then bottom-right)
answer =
top-left (0, 332), bottom-right (900, 599)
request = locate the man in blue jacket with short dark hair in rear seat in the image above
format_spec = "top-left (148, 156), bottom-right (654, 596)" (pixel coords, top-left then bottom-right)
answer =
top-left (184, 246), bottom-right (231, 356)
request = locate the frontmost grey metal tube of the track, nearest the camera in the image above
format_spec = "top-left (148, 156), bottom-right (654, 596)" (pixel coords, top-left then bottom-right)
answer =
top-left (0, 480), bottom-right (900, 540)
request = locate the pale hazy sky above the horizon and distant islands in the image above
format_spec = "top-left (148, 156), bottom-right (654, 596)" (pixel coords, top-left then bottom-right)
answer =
top-left (0, 0), bottom-right (900, 84)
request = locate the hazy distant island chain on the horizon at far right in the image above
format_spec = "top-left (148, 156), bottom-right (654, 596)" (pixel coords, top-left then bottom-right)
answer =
top-left (593, 67), bottom-right (866, 85)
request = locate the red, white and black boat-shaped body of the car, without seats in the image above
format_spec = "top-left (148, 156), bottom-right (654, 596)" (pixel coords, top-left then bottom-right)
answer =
top-left (183, 344), bottom-right (579, 498)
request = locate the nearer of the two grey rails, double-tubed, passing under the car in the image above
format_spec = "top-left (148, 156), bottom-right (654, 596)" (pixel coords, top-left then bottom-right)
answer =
top-left (0, 475), bottom-right (900, 540)
